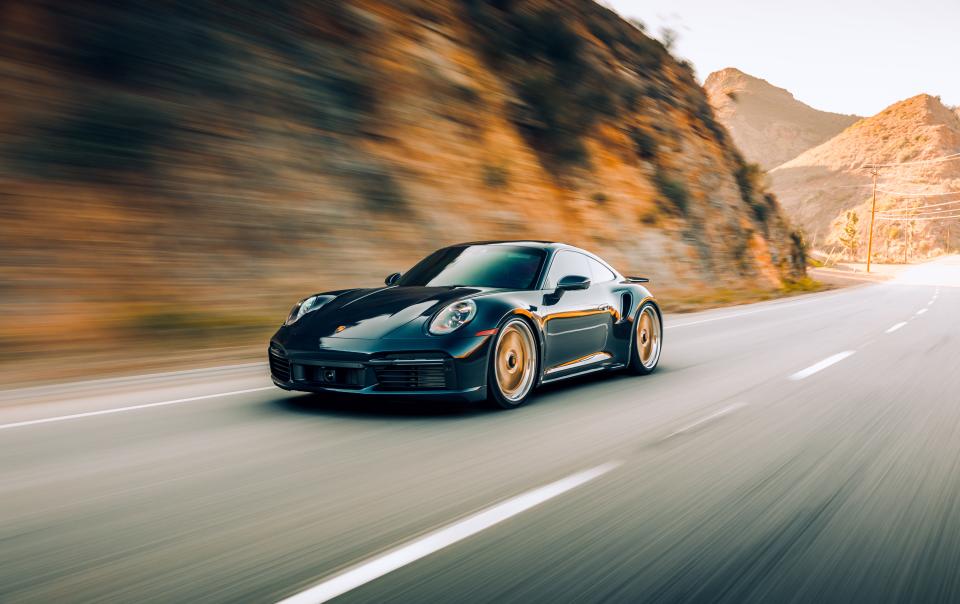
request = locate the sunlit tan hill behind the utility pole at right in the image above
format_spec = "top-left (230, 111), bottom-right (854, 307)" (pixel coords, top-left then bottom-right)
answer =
top-left (770, 94), bottom-right (960, 260)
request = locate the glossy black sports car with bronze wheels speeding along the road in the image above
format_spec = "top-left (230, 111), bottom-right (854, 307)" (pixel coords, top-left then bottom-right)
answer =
top-left (269, 241), bottom-right (663, 408)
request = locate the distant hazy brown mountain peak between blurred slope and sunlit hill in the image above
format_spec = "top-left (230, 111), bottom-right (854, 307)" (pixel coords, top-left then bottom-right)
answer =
top-left (703, 67), bottom-right (859, 169)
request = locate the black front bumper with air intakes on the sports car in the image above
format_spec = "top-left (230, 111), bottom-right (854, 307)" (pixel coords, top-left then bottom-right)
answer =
top-left (268, 336), bottom-right (489, 401)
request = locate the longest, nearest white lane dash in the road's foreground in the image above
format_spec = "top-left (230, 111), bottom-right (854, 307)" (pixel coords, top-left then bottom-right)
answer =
top-left (279, 461), bottom-right (623, 604)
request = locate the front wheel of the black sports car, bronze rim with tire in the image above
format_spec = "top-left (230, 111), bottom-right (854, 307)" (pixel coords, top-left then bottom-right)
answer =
top-left (487, 317), bottom-right (540, 409)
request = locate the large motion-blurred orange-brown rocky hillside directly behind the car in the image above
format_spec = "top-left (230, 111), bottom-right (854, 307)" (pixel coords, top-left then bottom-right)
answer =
top-left (0, 0), bottom-right (804, 372)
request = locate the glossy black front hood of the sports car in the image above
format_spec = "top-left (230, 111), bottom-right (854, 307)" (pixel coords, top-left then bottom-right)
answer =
top-left (294, 287), bottom-right (492, 339)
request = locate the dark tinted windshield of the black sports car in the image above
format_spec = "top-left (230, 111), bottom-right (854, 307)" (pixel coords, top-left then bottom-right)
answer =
top-left (398, 245), bottom-right (546, 289)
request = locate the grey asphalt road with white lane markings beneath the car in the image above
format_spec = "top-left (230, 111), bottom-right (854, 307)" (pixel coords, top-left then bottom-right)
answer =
top-left (0, 257), bottom-right (960, 602)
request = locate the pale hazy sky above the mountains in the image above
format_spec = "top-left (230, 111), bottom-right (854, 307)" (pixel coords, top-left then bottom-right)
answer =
top-left (601, 0), bottom-right (960, 115)
